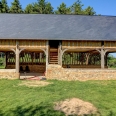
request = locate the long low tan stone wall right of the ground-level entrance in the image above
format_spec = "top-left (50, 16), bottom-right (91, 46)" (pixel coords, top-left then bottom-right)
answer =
top-left (46, 65), bottom-right (116, 81)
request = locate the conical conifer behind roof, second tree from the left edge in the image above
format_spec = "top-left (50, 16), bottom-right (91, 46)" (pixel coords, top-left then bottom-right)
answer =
top-left (10, 0), bottom-right (23, 13)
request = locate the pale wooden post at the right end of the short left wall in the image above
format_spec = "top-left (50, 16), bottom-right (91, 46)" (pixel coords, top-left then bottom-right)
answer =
top-left (15, 41), bottom-right (19, 73)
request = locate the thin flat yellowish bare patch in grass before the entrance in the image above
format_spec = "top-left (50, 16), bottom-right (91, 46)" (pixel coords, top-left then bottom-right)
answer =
top-left (19, 80), bottom-right (52, 87)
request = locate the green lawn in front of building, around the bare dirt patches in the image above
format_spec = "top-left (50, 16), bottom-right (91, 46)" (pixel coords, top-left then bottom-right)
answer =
top-left (0, 80), bottom-right (116, 116)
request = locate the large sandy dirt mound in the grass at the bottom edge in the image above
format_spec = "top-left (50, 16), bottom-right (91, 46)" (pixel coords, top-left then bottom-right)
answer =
top-left (54, 98), bottom-right (99, 116)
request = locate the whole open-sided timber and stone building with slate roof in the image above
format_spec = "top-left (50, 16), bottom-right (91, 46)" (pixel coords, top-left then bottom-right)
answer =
top-left (0, 14), bottom-right (116, 80)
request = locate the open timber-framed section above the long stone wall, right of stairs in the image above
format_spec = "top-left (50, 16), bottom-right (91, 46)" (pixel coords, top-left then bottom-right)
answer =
top-left (59, 40), bottom-right (116, 69)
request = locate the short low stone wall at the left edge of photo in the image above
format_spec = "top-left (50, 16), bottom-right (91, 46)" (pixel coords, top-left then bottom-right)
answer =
top-left (0, 69), bottom-right (20, 79)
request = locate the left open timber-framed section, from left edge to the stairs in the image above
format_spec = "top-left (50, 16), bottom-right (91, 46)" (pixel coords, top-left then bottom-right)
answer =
top-left (0, 40), bottom-right (47, 78)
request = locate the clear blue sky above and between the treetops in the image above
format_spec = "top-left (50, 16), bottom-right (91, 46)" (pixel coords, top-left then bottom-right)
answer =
top-left (7, 0), bottom-right (116, 16)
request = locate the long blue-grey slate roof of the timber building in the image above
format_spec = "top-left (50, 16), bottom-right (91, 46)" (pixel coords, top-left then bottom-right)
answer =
top-left (0, 14), bottom-right (116, 41)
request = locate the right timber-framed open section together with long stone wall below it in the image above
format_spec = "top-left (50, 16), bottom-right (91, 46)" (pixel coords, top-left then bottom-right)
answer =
top-left (46, 40), bottom-right (116, 80)
